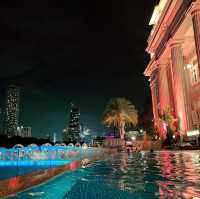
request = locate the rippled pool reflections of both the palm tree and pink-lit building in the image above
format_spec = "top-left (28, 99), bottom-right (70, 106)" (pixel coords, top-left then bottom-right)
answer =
top-left (106, 151), bottom-right (200, 199)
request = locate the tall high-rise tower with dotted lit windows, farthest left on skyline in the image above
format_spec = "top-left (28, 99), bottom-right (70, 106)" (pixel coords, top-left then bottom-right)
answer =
top-left (4, 85), bottom-right (20, 137)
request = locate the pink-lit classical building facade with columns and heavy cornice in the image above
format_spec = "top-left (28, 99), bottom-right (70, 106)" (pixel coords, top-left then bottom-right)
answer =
top-left (144, 0), bottom-right (200, 135)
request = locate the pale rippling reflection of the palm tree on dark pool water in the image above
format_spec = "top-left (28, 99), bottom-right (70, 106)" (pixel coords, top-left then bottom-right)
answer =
top-left (106, 153), bottom-right (152, 192)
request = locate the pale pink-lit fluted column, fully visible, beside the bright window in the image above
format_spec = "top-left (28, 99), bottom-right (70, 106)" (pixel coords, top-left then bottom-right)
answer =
top-left (171, 42), bottom-right (190, 133)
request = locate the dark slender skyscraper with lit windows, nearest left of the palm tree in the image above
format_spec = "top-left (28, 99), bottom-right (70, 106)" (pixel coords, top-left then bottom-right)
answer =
top-left (64, 103), bottom-right (80, 142)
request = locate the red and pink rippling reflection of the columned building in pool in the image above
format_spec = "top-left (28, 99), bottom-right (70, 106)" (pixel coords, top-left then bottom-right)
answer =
top-left (157, 151), bottom-right (200, 199)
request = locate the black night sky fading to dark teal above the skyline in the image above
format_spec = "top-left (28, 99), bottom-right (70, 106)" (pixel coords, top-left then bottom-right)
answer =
top-left (0, 0), bottom-right (158, 140)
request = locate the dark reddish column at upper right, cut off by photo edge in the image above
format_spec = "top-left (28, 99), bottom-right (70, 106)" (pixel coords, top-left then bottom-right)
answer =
top-left (191, 3), bottom-right (200, 73)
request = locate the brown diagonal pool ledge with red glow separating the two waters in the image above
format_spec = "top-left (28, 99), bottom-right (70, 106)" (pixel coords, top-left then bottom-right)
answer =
top-left (0, 150), bottom-right (116, 198)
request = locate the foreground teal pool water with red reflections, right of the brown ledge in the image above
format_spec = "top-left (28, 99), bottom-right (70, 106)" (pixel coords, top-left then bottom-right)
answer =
top-left (10, 151), bottom-right (200, 199)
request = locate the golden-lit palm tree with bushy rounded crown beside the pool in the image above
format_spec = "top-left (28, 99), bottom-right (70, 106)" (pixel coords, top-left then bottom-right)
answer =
top-left (103, 98), bottom-right (138, 140)
